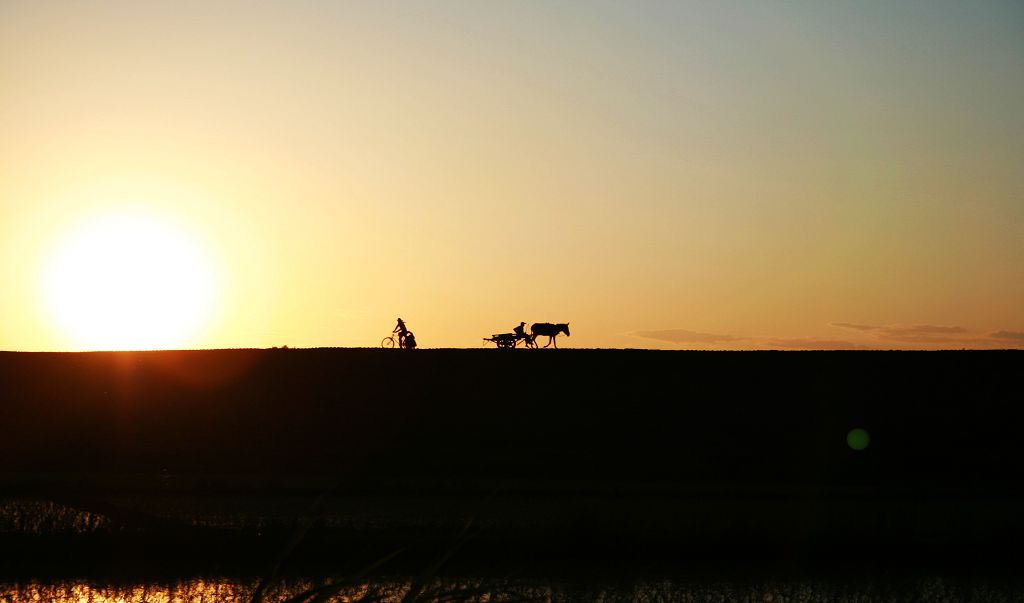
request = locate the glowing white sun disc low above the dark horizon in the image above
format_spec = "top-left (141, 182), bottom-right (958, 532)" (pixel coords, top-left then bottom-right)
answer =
top-left (43, 214), bottom-right (216, 350)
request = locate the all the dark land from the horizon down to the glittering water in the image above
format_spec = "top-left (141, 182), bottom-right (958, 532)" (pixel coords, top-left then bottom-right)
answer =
top-left (0, 349), bottom-right (1024, 574)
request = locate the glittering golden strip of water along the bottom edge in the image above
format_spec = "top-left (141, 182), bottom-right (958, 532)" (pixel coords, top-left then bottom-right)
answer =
top-left (0, 577), bottom-right (1022, 603)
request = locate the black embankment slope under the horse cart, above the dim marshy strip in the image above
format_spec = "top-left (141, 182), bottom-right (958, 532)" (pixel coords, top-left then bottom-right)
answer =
top-left (0, 349), bottom-right (1024, 489)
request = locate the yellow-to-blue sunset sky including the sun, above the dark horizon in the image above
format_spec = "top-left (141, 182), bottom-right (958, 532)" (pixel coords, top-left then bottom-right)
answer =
top-left (0, 0), bottom-right (1024, 350)
